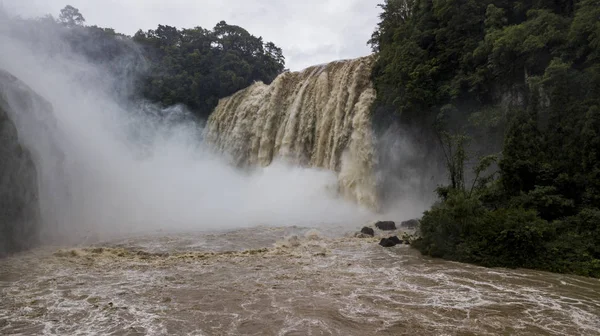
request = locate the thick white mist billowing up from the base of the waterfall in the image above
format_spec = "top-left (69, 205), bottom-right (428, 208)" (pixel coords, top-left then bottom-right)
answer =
top-left (0, 14), bottom-right (390, 247)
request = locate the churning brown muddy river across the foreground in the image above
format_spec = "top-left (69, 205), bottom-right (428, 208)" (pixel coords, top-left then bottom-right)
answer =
top-left (0, 227), bottom-right (600, 336)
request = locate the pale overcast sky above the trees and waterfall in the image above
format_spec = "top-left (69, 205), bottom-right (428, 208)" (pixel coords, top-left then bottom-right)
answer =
top-left (0, 0), bottom-right (383, 70)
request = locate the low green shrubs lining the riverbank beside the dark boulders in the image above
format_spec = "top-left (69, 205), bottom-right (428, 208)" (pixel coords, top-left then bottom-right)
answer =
top-left (413, 191), bottom-right (600, 277)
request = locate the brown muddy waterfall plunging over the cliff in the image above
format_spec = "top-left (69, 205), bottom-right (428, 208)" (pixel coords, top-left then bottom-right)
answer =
top-left (205, 56), bottom-right (379, 209)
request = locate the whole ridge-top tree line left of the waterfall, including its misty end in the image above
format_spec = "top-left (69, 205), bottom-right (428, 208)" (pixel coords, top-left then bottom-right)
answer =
top-left (0, 6), bottom-right (285, 118)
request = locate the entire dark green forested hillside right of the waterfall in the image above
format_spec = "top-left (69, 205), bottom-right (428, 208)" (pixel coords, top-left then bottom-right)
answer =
top-left (370, 0), bottom-right (600, 277)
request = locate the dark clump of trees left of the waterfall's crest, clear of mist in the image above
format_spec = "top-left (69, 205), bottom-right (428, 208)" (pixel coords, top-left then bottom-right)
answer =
top-left (133, 21), bottom-right (285, 117)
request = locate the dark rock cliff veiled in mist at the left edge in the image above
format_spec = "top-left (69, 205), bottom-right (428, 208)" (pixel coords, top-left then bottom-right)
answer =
top-left (0, 69), bottom-right (66, 256)
